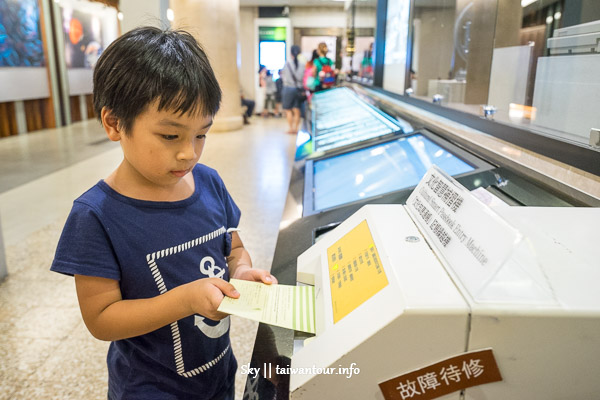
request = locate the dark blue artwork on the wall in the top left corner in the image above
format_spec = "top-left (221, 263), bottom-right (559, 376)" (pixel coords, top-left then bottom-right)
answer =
top-left (0, 0), bottom-right (44, 67)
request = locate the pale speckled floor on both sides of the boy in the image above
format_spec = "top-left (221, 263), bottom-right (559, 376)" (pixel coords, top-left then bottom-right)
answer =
top-left (0, 117), bottom-right (294, 400)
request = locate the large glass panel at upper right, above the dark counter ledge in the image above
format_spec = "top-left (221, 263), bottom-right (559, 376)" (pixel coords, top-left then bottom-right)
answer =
top-left (404, 0), bottom-right (600, 149)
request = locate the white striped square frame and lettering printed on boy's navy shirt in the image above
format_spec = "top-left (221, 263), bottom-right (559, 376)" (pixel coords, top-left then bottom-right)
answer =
top-left (146, 226), bottom-right (231, 378)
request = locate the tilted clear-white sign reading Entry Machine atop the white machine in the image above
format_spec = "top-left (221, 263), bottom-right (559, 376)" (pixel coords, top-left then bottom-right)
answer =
top-left (406, 165), bottom-right (522, 298)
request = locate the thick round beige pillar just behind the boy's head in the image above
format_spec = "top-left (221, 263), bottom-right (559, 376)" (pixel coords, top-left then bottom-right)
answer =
top-left (170, 0), bottom-right (244, 132)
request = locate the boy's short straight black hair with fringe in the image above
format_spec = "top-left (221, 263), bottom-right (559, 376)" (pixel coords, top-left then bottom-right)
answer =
top-left (94, 27), bottom-right (221, 134)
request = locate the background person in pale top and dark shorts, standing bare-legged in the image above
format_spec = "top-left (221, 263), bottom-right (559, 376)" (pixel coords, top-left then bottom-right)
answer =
top-left (281, 45), bottom-right (306, 134)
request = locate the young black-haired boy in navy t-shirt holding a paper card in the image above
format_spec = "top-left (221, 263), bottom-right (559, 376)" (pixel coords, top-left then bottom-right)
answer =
top-left (51, 27), bottom-right (276, 400)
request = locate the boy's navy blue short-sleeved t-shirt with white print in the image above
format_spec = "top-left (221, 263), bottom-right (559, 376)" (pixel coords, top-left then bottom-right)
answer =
top-left (51, 164), bottom-right (240, 400)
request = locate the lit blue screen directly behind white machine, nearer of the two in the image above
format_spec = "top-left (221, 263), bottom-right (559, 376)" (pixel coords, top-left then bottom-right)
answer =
top-left (313, 134), bottom-right (474, 210)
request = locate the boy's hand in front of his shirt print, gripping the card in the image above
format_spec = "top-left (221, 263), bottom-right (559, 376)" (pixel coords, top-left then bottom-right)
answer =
top-left (186, 278), bottom-right (240, 321)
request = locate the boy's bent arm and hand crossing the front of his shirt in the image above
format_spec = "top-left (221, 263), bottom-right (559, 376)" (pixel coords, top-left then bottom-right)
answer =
top-left (75, 275), bottom-right (239, 340)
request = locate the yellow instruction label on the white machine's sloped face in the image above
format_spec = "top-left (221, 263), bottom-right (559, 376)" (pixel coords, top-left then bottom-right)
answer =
top-left (327, 220), bottom-right (388, 323)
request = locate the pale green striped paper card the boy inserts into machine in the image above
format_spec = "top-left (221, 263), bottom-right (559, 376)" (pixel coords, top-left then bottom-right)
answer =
top-left (219, 279), bottom-right (315, 333)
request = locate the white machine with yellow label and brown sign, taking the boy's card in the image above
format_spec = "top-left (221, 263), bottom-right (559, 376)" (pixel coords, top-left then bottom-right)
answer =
top-left (290, 167), bottom-right (600, 400)
